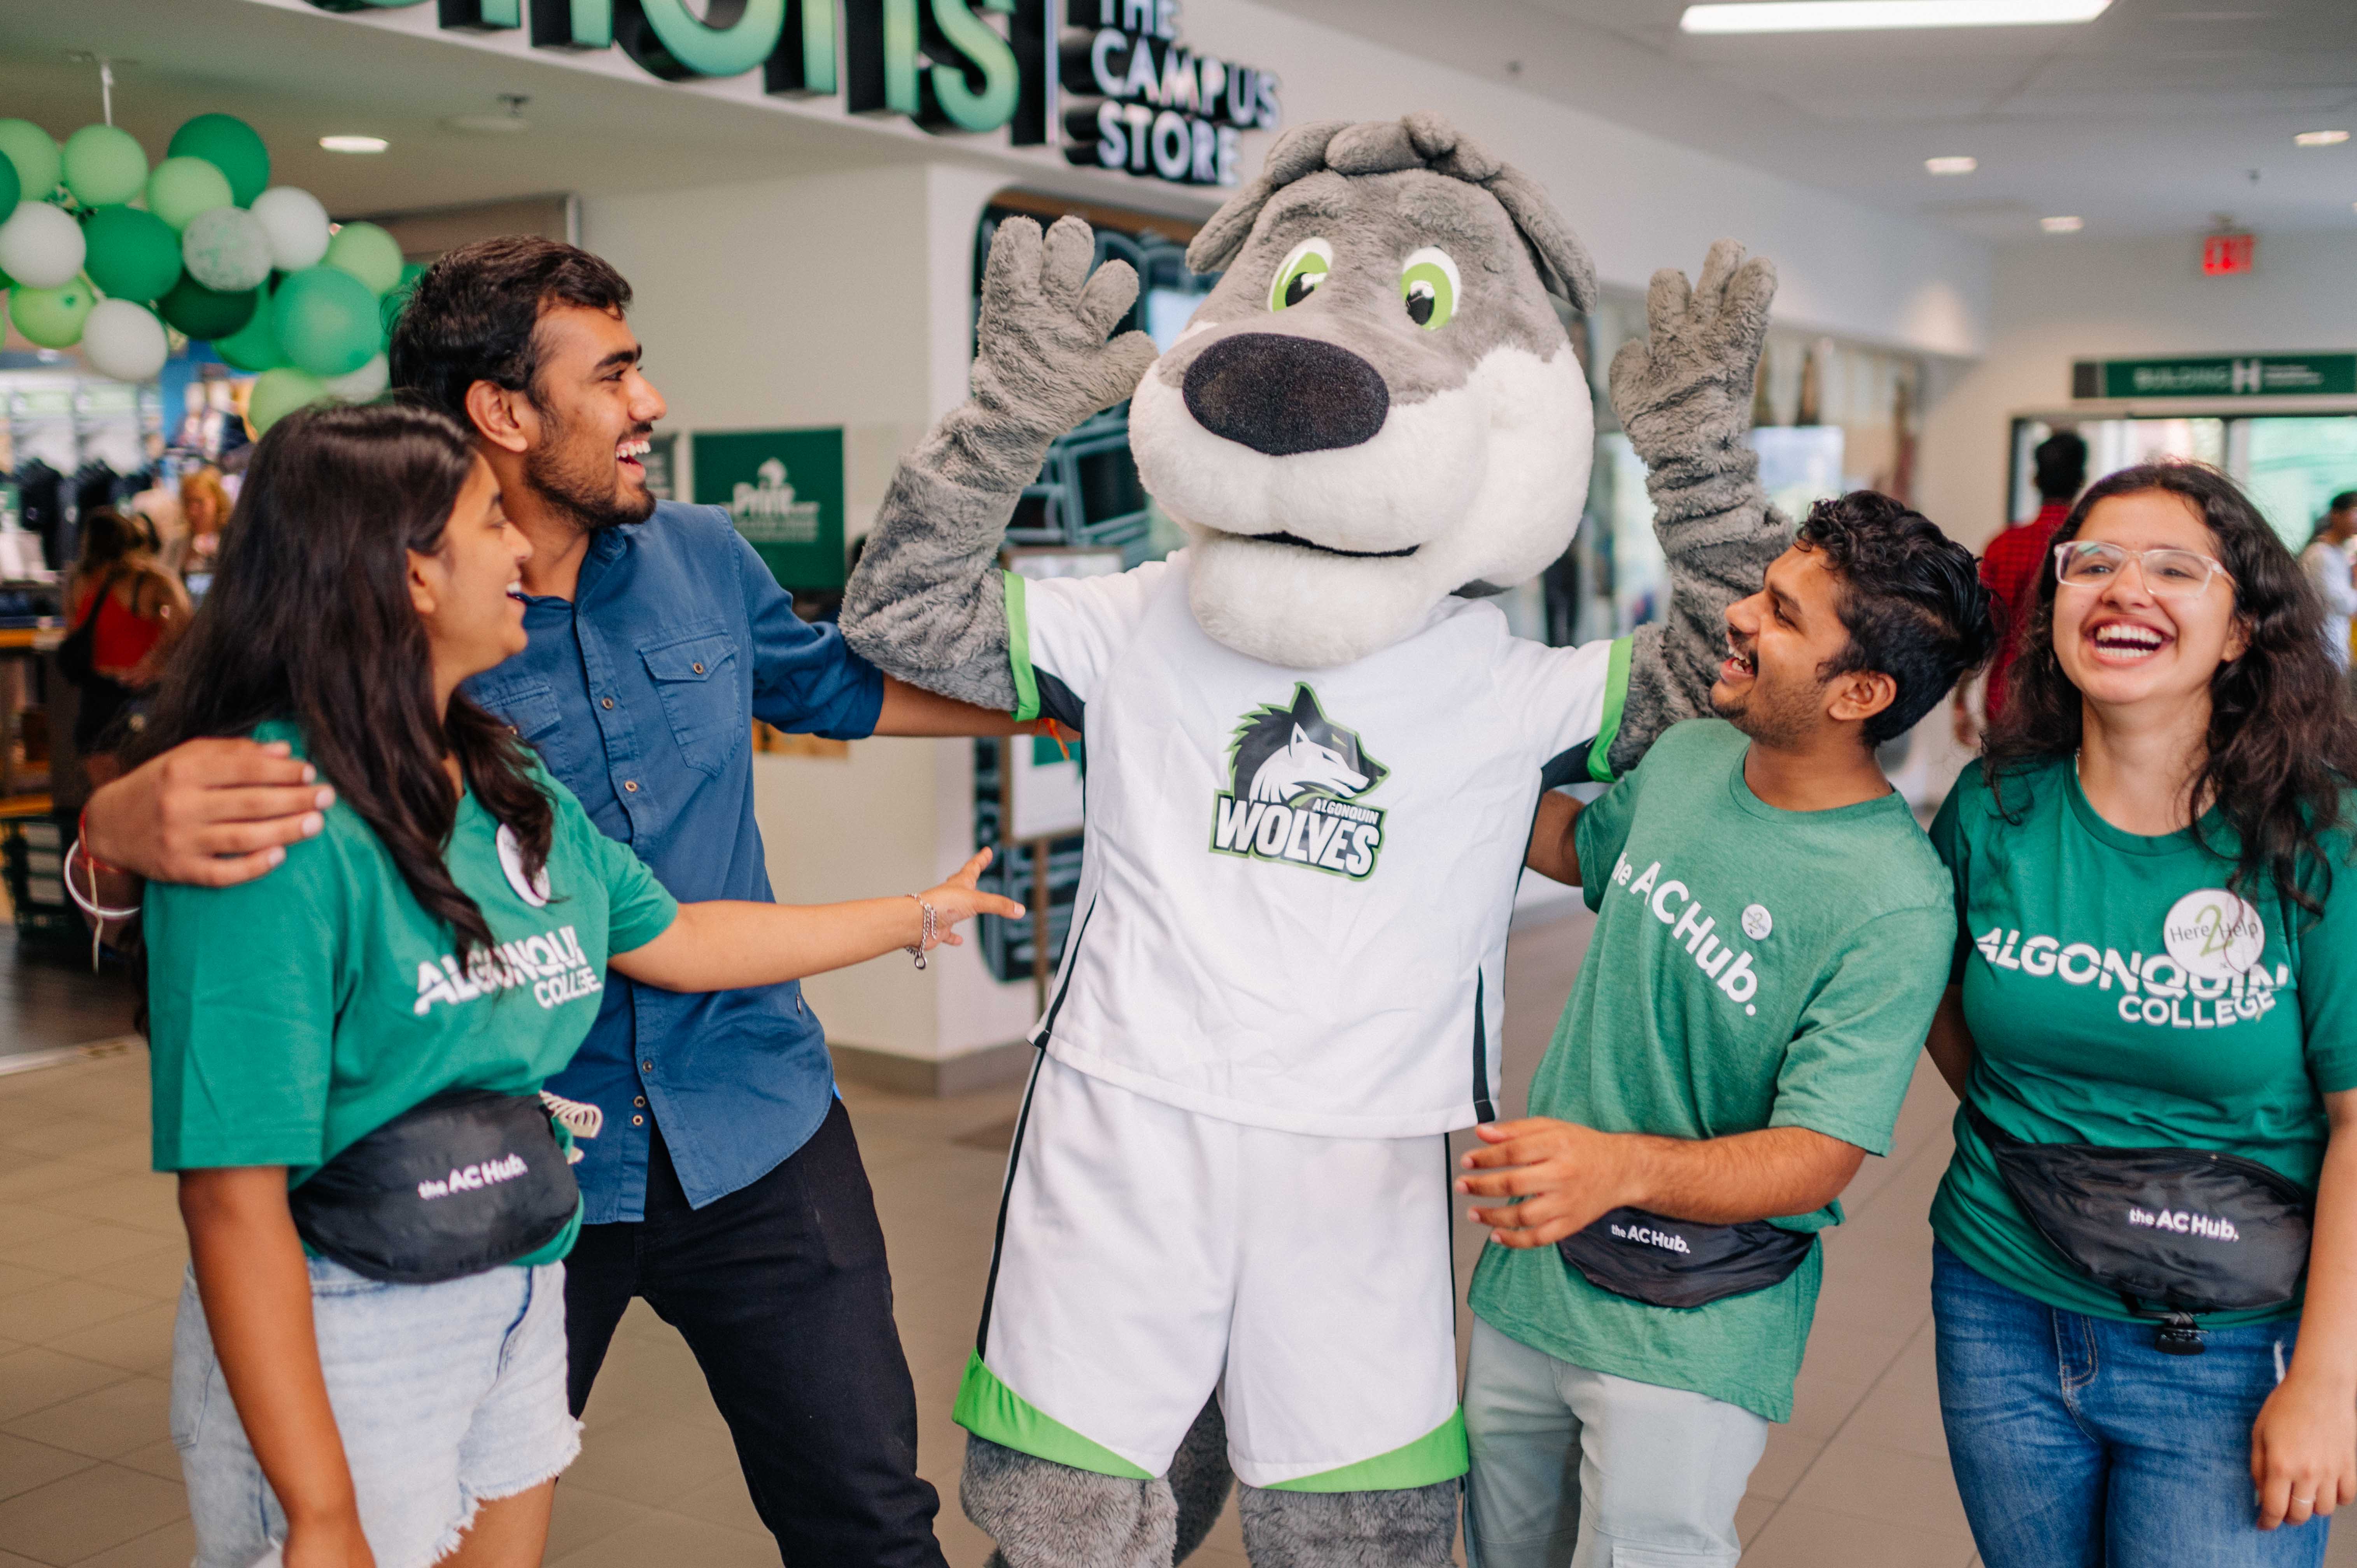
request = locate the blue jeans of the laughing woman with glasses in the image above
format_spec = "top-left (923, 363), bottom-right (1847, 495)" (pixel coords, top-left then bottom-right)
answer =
top-left (1930, 1245), bottom-right (2331, 1568)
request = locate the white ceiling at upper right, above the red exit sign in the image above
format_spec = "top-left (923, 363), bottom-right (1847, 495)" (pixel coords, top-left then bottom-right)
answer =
top-left (1263, 0), bottom-right (2357, 243)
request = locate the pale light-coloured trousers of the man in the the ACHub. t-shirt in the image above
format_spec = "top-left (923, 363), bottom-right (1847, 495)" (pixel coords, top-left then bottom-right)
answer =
top-left (1466, 1318), bottom-right (1768, 1568)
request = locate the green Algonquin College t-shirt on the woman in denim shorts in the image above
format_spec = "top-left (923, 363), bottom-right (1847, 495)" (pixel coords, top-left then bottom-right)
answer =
top-left (144, 721), bottom-right (679, 1262)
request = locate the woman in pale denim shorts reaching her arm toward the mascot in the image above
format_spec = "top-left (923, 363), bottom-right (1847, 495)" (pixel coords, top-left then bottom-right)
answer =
top-left (144, 406), bottom-right (1023, 1568)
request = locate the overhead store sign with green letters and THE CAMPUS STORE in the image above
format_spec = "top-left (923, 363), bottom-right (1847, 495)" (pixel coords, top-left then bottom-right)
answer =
top-left (311, 0), bottom-right (1280, 186)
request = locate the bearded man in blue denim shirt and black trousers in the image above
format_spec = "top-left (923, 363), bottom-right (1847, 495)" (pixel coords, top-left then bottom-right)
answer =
top-left (89, 238), bottom-right (1014, 1568)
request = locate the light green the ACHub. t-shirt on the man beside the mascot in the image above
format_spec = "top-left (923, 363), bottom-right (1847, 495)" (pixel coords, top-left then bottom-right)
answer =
top-left (1473, 719), bottom-right (1956, 1422)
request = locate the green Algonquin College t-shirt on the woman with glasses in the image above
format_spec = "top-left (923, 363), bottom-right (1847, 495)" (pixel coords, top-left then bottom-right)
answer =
top-left (1930, 761), bottom-right (2357, 1328)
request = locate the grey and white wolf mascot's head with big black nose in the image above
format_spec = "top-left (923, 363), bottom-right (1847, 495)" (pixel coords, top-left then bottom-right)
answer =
top-left (1129, 116), bottom-right (1596, 670)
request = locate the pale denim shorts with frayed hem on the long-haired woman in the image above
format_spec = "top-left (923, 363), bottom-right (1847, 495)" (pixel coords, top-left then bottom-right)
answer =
top-left (172, 1259), bottom-right (582, 1568)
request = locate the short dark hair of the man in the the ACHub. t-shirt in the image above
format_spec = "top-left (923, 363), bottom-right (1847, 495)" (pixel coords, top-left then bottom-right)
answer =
top-left (1794, 490), bottom-right (1996, 745)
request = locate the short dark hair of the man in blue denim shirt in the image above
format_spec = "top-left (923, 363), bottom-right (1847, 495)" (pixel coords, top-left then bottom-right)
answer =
top-left (387, 233), bottom-right (629, 429)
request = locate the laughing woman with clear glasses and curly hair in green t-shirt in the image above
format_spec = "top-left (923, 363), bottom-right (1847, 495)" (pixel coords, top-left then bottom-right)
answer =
top-left (1930, 464), bottom-right (2357, 1568)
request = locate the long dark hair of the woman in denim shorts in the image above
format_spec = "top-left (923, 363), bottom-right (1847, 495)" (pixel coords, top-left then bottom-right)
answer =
top-left (130, 403), bottom-right (556, 964)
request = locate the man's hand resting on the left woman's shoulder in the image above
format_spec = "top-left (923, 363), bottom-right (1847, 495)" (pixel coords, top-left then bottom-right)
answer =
top-left (82, 740), bottom-right (335, 887)
